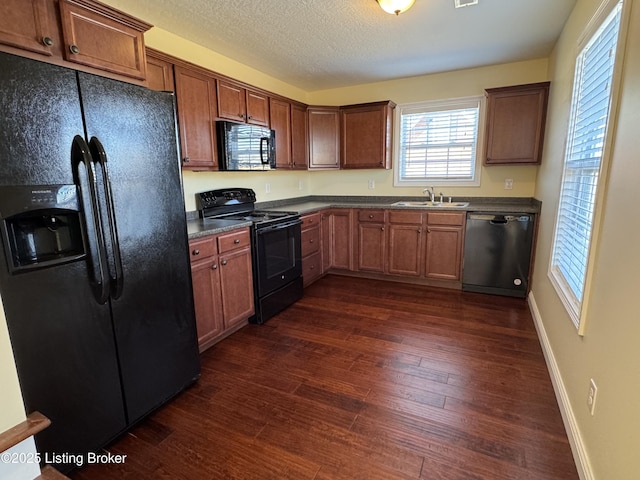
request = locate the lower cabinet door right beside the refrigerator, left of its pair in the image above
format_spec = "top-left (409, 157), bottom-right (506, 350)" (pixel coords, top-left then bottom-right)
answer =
top-left (191, 256), bottom-right (224, 351)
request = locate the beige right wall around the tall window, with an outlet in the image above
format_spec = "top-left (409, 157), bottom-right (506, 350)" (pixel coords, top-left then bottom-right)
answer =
top-left (532, 0), bottom-right (640, 480)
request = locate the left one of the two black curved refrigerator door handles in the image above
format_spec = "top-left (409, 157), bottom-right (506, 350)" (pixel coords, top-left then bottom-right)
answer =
top-left (71, 135), bottom-right (109, 305)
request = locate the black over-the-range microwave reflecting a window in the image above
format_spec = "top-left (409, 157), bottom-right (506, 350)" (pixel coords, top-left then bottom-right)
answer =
top-left (216, 120), bottom-right (276, 171)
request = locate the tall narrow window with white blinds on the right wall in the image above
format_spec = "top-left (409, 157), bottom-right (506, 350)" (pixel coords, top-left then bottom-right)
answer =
top-left (549, 1), bottom-right (622, 328)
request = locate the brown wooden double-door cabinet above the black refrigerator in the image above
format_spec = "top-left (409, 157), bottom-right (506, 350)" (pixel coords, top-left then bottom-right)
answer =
top-left (0, 0), bottom-right (151, 81)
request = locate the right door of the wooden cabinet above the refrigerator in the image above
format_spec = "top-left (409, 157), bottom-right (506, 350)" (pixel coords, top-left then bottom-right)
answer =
top-left (60, 0), bottom-right (151, 80)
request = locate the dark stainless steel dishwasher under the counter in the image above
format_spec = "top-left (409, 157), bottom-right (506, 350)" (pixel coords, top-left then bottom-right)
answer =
top-left (462, 212), bottom-right (535, 297)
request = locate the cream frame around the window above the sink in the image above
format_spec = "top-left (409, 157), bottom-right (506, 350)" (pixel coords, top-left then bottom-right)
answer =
top-left (393, 95), bottom-right (486, 187)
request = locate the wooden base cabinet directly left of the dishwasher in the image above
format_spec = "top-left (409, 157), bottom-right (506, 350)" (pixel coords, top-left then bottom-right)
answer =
top-left (425, 212), bottom-right (466, 281)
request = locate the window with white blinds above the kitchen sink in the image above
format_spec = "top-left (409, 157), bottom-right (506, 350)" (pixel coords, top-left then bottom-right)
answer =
top-left (395, 97), bottom-right (483, 186)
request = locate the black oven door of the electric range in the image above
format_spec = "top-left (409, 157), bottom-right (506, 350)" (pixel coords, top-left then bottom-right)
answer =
top-left (254, 218), bottom-right (302, 297)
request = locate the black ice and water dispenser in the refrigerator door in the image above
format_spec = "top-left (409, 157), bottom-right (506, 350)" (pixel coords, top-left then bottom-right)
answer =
top-left (0, 185), bottom-right (85, 273)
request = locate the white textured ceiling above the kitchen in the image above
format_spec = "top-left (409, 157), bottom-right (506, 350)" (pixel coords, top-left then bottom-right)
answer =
top-left (104, 0), bottom-right (576, 91)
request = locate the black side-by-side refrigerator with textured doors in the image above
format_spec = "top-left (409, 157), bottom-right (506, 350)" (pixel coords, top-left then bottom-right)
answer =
top-left (0, 53), bottom-right (200, 471)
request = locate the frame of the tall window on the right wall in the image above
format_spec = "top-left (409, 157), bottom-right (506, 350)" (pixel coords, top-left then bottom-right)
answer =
top-left (547, 0), bottom-right (631, 336)
